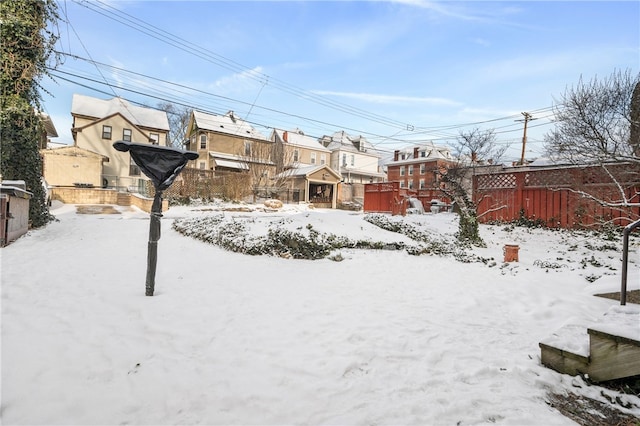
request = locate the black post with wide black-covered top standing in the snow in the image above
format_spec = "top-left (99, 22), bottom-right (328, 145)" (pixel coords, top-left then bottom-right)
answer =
top-left (113, 141), bottom-right (198, 296)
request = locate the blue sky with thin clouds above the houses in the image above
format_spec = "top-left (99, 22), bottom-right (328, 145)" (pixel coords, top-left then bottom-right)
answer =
top-left (42, 0), bottom-right (640, 159)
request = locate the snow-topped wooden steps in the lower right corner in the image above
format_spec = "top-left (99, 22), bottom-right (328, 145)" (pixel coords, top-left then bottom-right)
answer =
top-left (539, 311), bottom-right (640, 382)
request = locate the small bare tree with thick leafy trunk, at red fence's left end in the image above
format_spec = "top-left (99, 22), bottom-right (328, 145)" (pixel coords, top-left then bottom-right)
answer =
top-left (439, 128), bottom-right (508, 246)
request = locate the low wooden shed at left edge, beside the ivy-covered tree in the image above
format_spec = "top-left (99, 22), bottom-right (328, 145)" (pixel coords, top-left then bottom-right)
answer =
top-left (0, 180), bottom-right (33, 247)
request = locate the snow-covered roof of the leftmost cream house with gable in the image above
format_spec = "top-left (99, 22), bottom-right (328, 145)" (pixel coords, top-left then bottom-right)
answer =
top-left (71, 94), bottom-right (170, 131)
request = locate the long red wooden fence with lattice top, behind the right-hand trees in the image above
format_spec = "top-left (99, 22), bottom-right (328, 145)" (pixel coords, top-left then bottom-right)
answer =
top-left (473, 164), bottom-right (640, 228)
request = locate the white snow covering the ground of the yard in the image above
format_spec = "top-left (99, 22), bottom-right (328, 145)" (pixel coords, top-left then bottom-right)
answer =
top-left (0, 203), bottom-right (640, 425)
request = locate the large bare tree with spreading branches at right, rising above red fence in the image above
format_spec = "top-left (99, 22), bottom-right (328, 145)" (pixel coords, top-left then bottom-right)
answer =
top-left (545, 70), bottom-right (640, 213)
